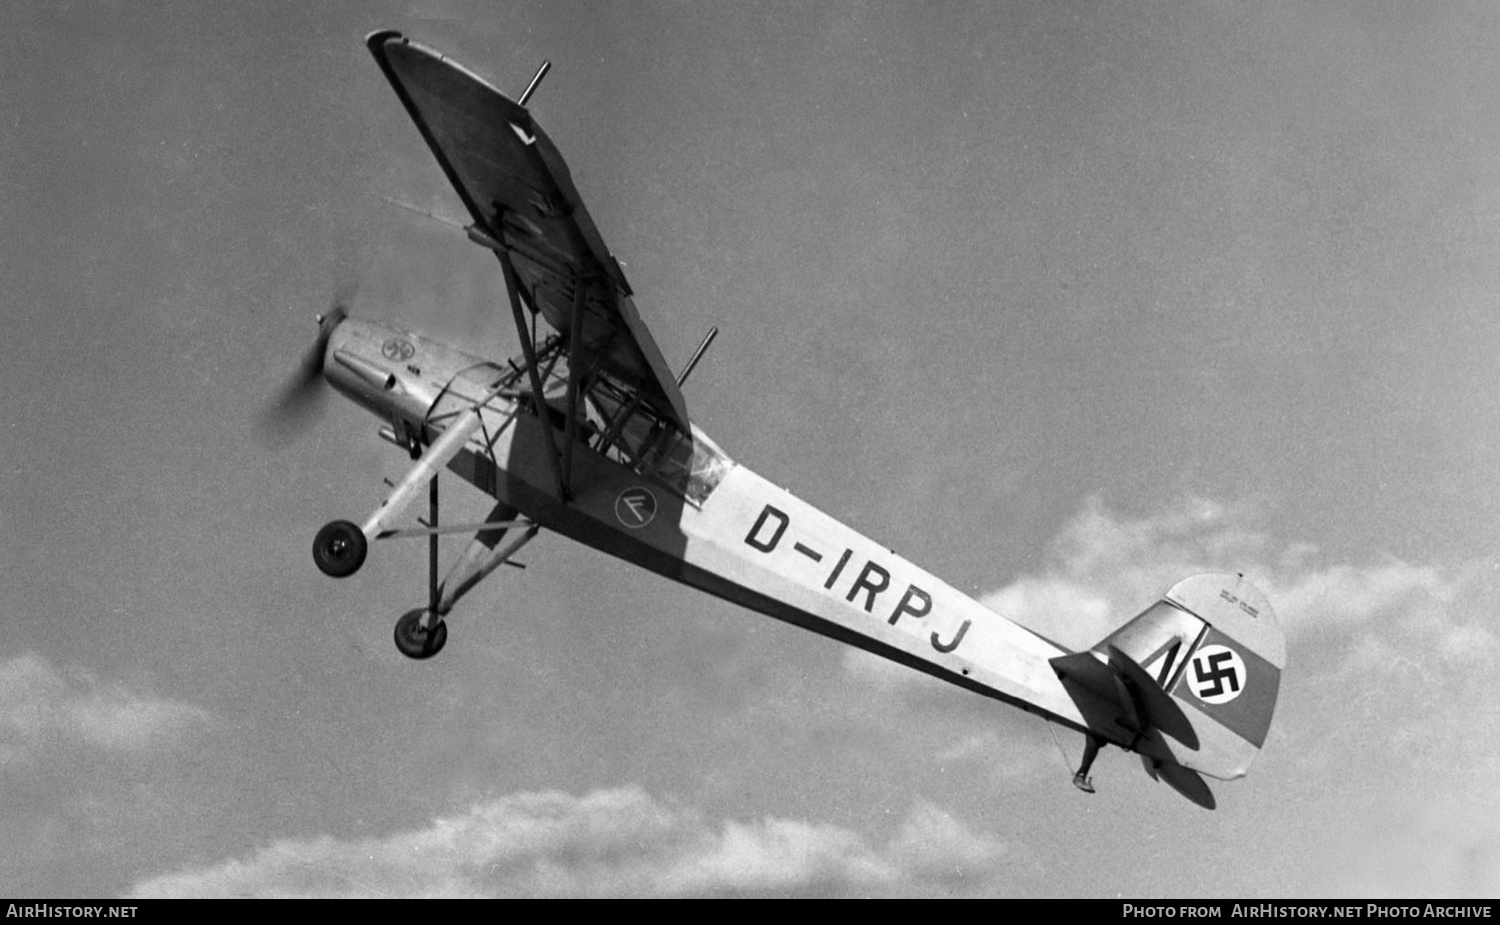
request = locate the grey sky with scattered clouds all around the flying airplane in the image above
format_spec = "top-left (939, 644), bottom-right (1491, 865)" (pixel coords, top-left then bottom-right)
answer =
top-left (0, 0), bottom-right (1500, 898)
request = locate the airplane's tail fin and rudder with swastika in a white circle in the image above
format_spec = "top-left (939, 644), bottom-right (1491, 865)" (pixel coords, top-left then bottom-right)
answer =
top-left (1053, 574), bottom-right (1287, 808)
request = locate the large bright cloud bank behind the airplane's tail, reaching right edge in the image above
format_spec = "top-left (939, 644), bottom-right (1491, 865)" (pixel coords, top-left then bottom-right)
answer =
top-left (845, 496), bottom-right (1500, 777)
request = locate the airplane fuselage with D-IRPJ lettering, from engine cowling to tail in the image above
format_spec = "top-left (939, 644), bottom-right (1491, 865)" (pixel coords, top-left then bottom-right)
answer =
top-left (324, 319), bottom-right (1124, 744)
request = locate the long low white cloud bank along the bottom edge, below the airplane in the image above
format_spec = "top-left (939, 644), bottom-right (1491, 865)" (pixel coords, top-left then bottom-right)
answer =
top-left (132, 787), bottom-right (1004, 898)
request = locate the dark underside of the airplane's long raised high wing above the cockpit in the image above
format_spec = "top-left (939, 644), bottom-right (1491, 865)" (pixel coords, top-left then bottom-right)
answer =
top-left (366, 31), bottom-right (690, 433)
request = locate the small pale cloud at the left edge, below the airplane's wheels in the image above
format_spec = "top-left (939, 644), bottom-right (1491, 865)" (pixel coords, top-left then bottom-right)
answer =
top-left (0, 654), bottom-right (209, 766)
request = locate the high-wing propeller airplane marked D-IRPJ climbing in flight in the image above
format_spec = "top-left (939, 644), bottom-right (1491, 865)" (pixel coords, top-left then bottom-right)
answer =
top-left (267, 31), bottom-right (1286, 810)
